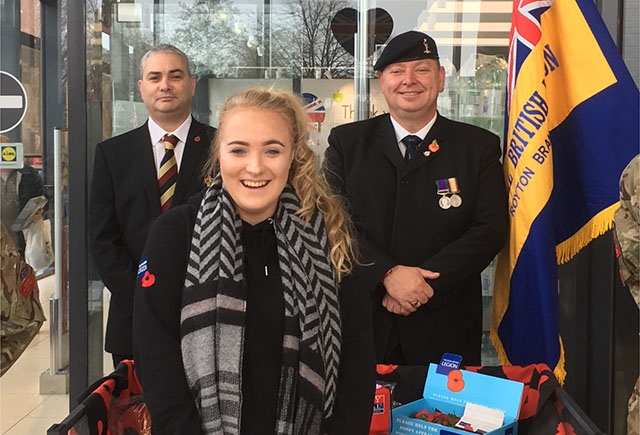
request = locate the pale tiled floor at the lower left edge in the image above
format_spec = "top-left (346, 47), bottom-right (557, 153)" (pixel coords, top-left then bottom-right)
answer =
top-left (0, 275), bottom-right (69, 435)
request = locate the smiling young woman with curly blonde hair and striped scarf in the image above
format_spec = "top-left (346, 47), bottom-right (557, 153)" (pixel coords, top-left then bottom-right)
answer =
top-left (134, 88), bottom-right (375, 435)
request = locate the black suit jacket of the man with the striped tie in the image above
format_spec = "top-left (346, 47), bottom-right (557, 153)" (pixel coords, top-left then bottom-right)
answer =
top-left (90, 119), bottom-right (215, 355)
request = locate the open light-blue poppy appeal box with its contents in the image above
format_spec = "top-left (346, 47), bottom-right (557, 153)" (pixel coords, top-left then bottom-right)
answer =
top-left (392, 354), bottom-right (524, 435)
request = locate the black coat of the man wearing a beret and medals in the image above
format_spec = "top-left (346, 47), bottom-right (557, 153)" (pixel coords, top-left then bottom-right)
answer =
top-left (324, 114), bottom-right (508, 365)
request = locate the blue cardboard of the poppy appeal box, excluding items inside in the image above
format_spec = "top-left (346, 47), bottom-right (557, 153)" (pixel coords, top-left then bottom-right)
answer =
top-left (392, 358), bottom-right (524, 435)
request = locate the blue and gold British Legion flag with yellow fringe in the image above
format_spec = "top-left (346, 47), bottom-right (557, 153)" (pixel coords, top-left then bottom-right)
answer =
top-left (491, 0), bottom-right (640, 382)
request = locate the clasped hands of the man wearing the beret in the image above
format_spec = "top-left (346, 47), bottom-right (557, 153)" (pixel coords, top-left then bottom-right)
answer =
top-left (382, 265), bottom-right (440, 316)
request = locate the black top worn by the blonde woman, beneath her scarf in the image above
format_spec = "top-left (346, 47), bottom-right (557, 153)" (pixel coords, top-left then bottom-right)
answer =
top-left (133, 198), bottom-right (375, 435)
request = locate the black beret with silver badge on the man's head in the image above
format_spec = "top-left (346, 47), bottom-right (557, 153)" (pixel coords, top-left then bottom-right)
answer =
top-left (373, 30), bottom-right (439, 71)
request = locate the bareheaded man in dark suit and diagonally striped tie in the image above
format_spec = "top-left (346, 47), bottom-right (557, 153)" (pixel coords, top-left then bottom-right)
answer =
top-left (90, 45), bottom-right (215, 366)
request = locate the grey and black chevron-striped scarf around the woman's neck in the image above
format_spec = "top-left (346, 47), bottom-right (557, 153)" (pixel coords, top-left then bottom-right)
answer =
top-left (181, 177), bottom-right (341, 435)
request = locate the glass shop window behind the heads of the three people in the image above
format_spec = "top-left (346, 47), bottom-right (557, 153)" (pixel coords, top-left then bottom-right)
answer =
top-left (87, 0), bottom-right (512, 374)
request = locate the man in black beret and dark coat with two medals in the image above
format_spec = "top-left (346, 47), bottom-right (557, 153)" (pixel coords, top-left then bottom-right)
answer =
top-left (324, 31), bottom-right (508, 365)
